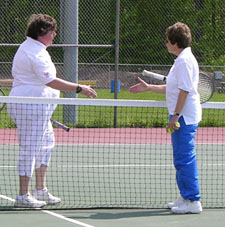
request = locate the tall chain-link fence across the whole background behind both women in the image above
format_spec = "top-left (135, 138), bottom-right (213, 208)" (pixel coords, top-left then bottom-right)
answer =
top-left (0, 0), bottom-right (225, 98)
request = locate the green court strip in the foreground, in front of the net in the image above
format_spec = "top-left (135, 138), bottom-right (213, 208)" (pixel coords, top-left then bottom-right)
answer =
top-left (0, 209), bottom-right (225, 227)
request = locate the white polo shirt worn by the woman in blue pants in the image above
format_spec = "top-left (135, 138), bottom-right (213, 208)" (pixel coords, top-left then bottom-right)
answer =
top-left (166, 47), bottom-right (202, 125)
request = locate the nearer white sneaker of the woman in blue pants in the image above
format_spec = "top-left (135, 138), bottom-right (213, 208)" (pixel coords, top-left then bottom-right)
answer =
top-left (171, 200), bottom-right (202, 214)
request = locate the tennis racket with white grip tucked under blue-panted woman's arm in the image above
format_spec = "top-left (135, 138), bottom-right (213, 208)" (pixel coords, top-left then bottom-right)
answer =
top-left (142, 70), bottom-right (215, 104)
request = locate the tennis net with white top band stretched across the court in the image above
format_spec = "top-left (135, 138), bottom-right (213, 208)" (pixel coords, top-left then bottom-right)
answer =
top-left (0, 97), bottom-right (225, 210)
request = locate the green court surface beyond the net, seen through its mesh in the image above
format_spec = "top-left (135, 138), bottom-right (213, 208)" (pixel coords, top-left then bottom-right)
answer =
top-left (0, 144), bottom-right (225, 210)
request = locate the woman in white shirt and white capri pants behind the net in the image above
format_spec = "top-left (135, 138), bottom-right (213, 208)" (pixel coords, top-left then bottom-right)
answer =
top-left (8, 14), bottom-right (97, 208)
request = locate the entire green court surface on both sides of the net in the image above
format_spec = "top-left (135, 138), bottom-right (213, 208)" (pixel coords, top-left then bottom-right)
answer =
top-left (0, 137), bottom-right (225, 227)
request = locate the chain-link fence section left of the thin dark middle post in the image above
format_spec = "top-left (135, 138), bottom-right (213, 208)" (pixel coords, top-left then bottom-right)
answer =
top-left (0, 0), bottom-right (115, 94)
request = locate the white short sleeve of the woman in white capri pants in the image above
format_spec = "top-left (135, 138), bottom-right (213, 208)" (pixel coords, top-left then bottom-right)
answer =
top-left (32, 50), bottom-right (56, 84)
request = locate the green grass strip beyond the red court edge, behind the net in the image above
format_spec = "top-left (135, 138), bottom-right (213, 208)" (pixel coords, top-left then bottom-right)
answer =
top-left (0, 89), bottom-right (225, 128)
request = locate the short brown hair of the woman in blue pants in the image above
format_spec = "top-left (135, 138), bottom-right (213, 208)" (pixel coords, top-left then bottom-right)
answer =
top-left (166, 22), bottom-right (192, 48)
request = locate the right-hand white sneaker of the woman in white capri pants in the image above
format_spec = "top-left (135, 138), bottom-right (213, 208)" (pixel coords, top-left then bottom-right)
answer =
top-left (32, 188), bottom-right (61, 205)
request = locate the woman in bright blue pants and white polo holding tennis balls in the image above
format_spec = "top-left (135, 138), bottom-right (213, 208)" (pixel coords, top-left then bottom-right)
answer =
top-left (130, 22), bottom-right (202, 213)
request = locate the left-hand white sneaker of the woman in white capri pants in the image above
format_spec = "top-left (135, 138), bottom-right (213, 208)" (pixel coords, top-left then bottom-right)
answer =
top-left (14, 193), bottom-right (46, 208)
